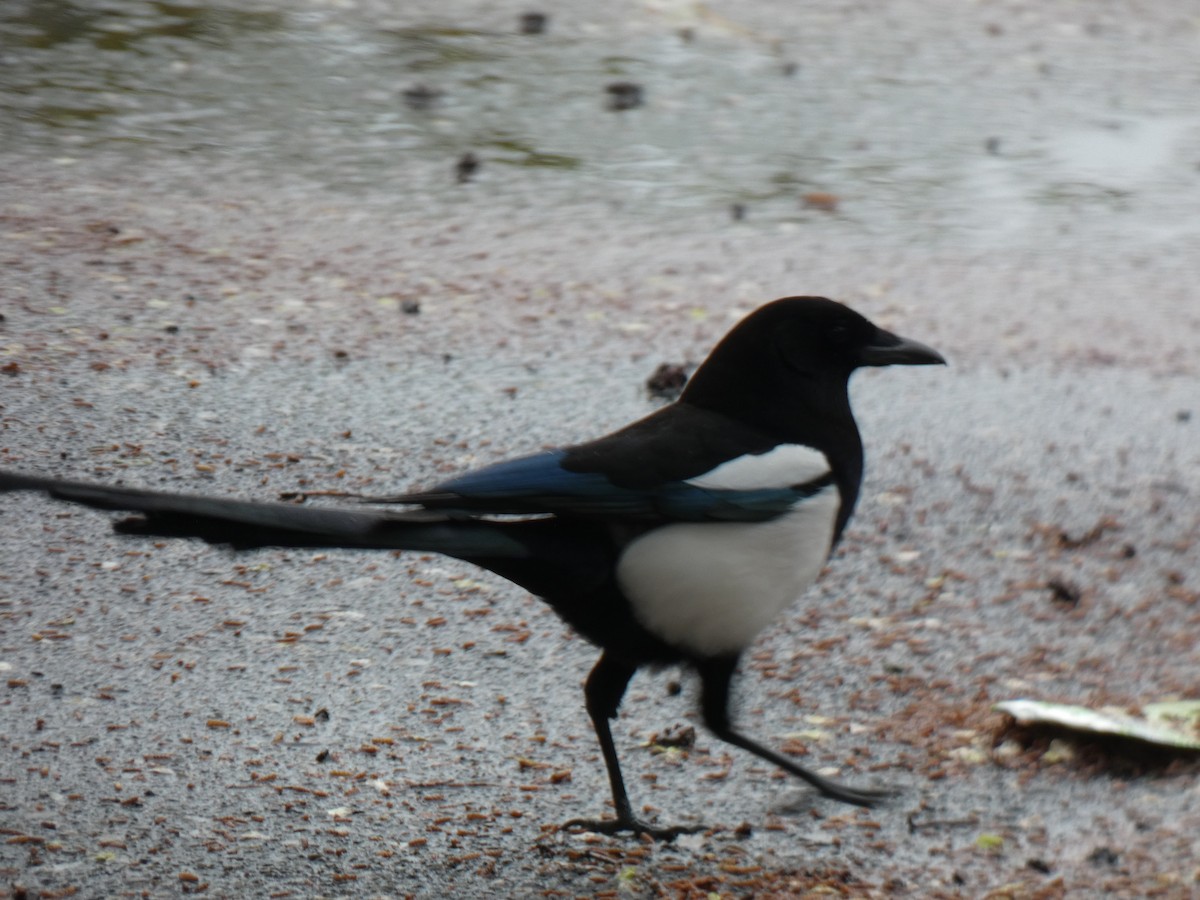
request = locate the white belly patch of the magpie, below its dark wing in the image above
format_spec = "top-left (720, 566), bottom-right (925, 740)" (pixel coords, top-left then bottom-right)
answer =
top-left (617, 485), bottom-right (840, 655)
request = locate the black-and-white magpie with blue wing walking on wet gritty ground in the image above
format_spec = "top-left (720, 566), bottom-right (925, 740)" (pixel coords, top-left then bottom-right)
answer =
top-left (0, 296), bottom-right (946, 840)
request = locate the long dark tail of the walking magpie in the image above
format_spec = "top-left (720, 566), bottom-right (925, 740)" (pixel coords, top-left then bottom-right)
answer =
top-left (0, 472), bottom-right (530, 560)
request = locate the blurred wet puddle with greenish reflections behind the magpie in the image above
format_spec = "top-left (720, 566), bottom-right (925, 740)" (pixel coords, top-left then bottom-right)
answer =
top-left (0, 0), bottom-right (1200, 251)
